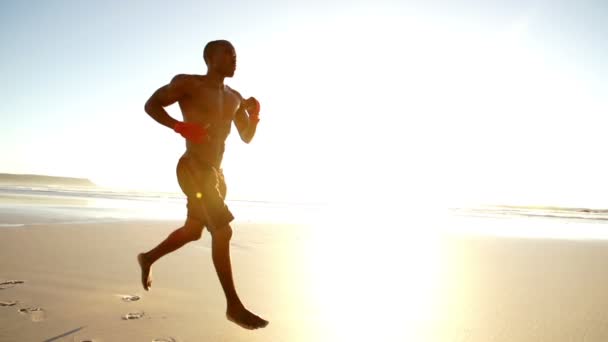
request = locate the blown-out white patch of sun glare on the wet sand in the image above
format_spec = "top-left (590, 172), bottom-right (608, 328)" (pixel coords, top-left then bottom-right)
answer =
top-left (305, 202), bottom-right (444, 341)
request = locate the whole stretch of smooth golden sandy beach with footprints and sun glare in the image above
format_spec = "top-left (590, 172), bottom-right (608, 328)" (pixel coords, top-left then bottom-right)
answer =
top-left (0, 212), bottom-right (608, 342)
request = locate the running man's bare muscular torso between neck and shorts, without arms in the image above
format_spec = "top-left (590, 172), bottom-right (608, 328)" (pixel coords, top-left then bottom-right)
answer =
top-left (178, 75), bottom-right (242, 168)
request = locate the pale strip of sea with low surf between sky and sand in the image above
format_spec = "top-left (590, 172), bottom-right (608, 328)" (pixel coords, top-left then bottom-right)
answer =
top-left (0, 185), bottom-right (608, 239)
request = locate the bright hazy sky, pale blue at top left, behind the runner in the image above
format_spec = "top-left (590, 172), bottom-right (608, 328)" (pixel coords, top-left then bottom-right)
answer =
top-left (0, 0), bottom-right (608, 207)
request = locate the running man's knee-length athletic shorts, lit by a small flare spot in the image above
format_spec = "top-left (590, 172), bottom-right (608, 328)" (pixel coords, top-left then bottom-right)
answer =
top-left (177, 156), bottom-right (234, 232)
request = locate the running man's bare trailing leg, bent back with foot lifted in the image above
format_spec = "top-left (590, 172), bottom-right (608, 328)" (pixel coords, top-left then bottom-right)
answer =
top-left (137, 218), bottom-right (204, 291)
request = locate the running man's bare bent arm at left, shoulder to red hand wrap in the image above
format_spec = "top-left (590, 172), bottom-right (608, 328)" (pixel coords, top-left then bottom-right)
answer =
top-left (144, 75), bottom-right (188, 129)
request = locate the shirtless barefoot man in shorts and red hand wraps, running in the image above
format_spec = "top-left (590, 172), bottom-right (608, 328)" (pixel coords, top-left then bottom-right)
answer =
top-left (137, 40), bottom-right (268, 329)
